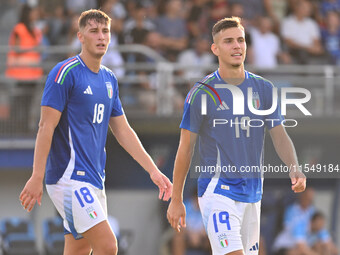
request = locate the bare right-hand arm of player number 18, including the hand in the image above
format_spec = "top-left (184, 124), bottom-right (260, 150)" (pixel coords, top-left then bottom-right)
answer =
top-left (109, 114), bottom-right (172, 201)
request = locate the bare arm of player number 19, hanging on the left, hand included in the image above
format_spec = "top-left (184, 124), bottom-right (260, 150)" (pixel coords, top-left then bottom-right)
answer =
top-left (167, 128), bottom-right (197, 232)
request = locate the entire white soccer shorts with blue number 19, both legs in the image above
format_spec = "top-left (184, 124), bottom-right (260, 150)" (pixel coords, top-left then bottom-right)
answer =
top-left (198, 194), bottom-right (261, 255)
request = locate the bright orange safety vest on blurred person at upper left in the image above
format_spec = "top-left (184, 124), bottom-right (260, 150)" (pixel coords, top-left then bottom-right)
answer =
top-left (6, 23), bottom-right (43, 80)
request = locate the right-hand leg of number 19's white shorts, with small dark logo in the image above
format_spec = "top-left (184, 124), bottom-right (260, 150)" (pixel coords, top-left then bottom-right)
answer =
top-left (241, 201), bottom-right (261, 255)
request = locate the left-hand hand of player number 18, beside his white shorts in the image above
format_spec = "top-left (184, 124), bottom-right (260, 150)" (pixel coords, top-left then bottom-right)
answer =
top-left (19, 176), bottom-right (43, 212)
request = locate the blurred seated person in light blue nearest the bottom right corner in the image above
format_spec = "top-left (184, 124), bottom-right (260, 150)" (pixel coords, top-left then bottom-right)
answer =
top-left (306, 212), bottom-right (338, 255)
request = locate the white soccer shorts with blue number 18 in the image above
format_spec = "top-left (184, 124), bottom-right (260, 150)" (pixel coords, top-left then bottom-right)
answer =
top-left (46, 178), bottom-right (107, 239)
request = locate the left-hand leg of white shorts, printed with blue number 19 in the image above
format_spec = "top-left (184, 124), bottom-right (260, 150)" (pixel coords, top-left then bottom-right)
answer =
top-left (199, 194), bottom-right (245, 255)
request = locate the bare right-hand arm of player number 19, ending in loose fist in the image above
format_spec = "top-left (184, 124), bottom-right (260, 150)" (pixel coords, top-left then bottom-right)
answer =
top-left (269, 125), bottom-right (306, 193)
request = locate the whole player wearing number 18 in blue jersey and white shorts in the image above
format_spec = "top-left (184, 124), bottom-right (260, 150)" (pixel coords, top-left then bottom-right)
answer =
top-left (20, 10), bottom-right (172, 255)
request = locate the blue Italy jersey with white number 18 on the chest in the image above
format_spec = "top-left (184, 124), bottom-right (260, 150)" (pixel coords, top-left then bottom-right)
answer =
top-left (41, 55), bottom-right (123, 189)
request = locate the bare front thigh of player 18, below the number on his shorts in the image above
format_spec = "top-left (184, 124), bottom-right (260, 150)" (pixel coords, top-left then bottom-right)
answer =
top-left (82, 220), bottom-right (118, 254)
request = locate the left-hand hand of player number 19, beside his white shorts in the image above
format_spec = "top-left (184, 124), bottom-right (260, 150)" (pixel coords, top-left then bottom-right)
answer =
top-left (167, 200), bottom-right (186, 233)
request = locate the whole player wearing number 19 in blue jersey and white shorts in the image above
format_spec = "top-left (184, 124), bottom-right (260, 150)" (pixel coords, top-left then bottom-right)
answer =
top-left (167, 17), bottom-right (306, 255)
